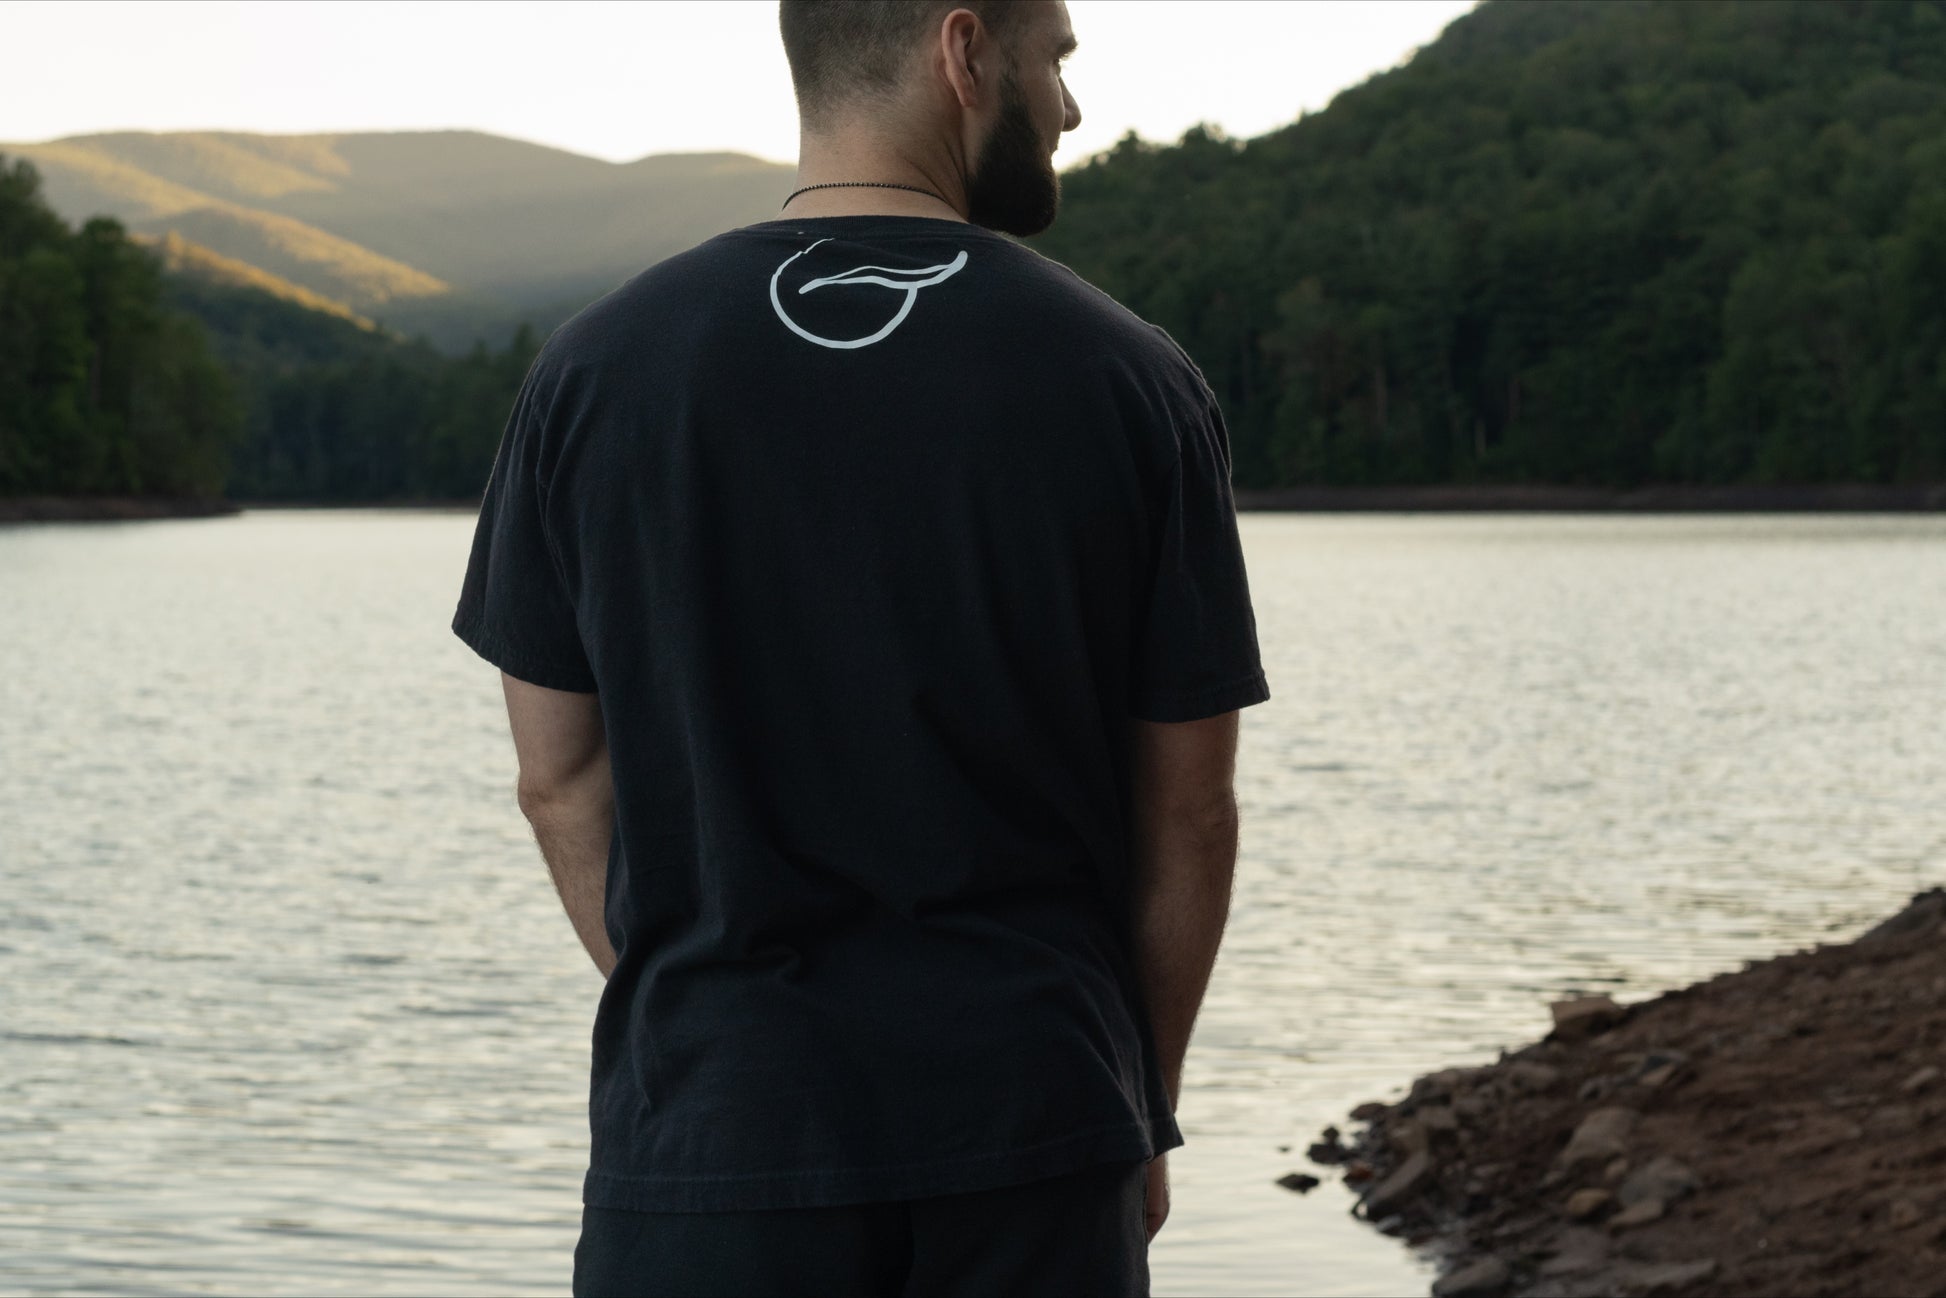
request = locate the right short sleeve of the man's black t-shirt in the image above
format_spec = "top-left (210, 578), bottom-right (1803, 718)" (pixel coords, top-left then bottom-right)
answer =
top-left (1129, 389), bottom-right (1271, 722)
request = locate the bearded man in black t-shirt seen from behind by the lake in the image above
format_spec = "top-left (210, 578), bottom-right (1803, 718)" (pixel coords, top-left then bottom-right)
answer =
top-left (453, 0), bottom-right (1269, 1296)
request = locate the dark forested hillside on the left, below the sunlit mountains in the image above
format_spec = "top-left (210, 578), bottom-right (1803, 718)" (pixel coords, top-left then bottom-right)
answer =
top-left (0, 158), bottom-right (539, 500)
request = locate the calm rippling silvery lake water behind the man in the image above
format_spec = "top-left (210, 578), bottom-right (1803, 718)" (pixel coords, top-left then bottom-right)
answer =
top-left (0, 512), bottom-right (1946, 1294)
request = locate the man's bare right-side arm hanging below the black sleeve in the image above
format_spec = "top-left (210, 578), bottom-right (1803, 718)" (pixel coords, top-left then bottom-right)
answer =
top-left (1131, 712), bottom-right (1238, 1109)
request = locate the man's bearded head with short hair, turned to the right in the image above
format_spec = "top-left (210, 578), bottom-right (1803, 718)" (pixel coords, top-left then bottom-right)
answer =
top-left (778, 0), bottom-right (1082, 235)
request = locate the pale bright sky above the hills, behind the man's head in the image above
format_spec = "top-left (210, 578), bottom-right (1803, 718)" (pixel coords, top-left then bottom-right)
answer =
top-left (0, 0), bottom-right (1473, 165)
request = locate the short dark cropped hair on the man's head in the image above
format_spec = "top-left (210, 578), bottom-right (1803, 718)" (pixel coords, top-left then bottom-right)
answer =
top-left (776, 0), bottom-right (1014, 126)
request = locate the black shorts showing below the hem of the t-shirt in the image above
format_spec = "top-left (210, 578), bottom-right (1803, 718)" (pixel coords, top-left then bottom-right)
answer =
top-left (574, 1160), bottom-right (1148, 1298)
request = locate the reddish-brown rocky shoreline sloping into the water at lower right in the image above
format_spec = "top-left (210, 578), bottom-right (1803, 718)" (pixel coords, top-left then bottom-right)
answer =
top-left (1306, 887), bottom-right (1946, 1298)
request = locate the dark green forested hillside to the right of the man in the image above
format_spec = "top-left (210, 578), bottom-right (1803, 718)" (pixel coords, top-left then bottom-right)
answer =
top-left (1035, 0), bottom-right (1946, 487)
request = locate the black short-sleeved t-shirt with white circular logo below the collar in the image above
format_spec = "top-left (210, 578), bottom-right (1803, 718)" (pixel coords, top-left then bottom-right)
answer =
top-left (453, 216), bottom-right (1269, 1212)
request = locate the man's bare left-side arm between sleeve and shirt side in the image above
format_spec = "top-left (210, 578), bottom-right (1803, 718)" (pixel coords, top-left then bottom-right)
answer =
top-left (500, 671), bottom-right (615, 977)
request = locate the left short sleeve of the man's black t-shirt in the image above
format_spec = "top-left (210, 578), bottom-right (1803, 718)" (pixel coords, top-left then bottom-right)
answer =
top-left (453, 364), bottom-right (595, 695)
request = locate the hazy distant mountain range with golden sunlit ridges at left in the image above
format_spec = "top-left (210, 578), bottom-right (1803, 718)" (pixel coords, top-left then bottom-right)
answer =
top-left (0, 130), bottom-right (792, 348)
